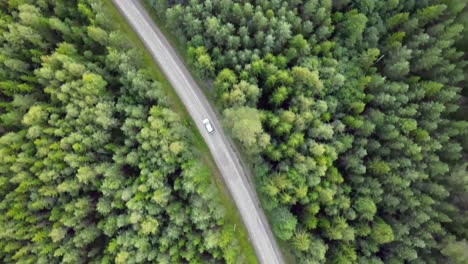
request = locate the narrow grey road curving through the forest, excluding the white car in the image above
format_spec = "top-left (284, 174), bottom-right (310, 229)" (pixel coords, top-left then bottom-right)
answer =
top-left (112, 0), bottom-right (284, 264)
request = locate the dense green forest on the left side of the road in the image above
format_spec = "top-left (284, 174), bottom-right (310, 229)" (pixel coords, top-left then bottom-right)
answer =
top-left (0, 0), bottom-right (250, 264)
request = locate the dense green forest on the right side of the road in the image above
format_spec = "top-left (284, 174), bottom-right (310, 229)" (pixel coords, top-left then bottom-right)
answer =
top-left (146, 0), bottom-right (468, 263)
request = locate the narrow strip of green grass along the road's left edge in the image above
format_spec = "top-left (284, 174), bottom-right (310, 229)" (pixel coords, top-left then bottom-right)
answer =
top-left (103, 0), bottom-right (258, 263)
